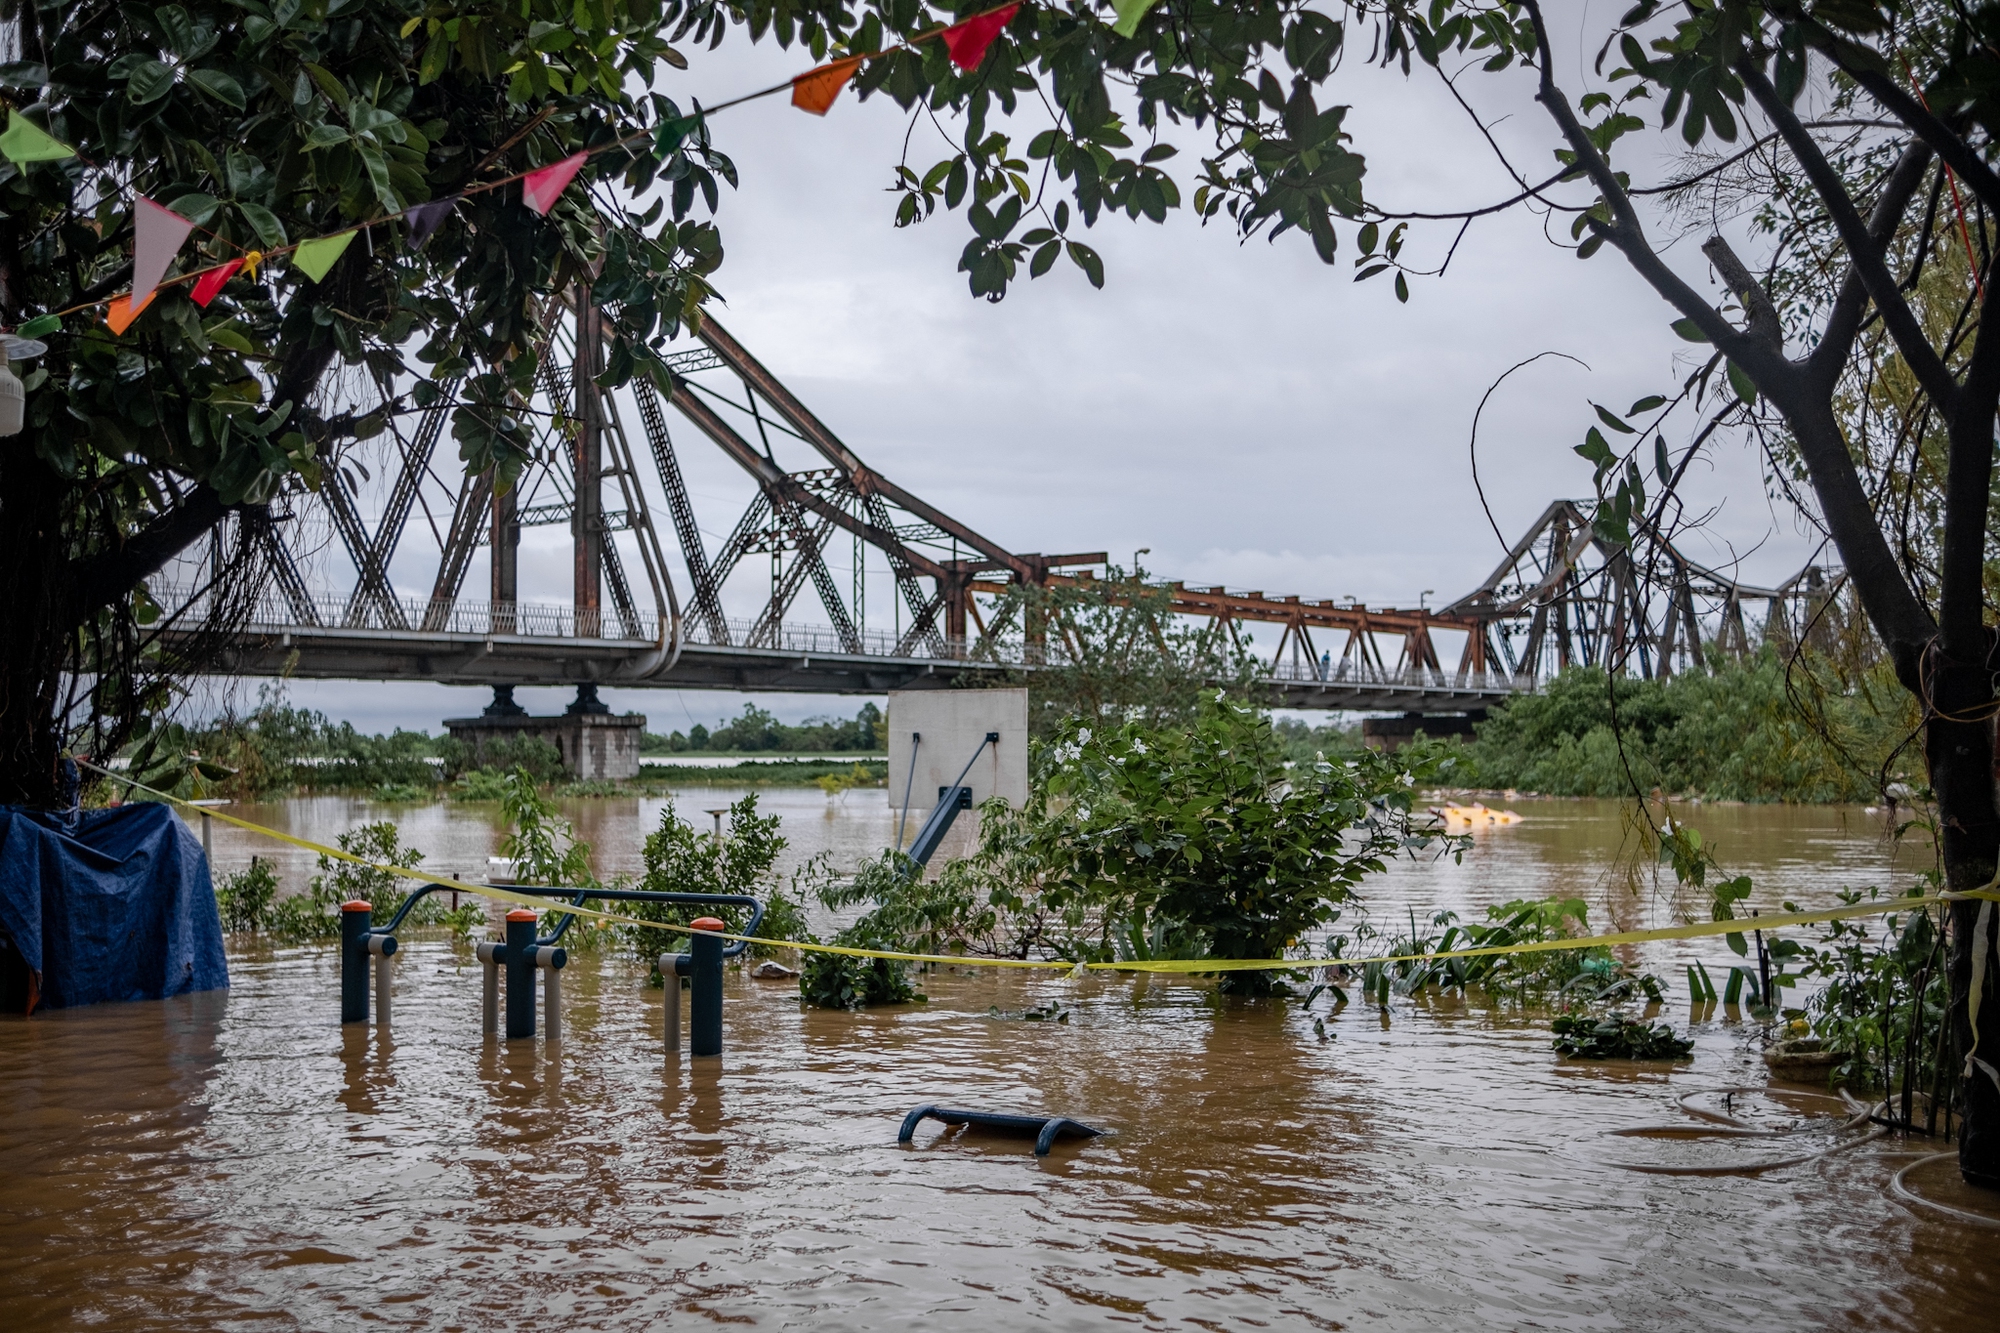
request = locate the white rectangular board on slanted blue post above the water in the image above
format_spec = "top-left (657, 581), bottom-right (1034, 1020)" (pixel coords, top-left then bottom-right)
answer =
top-left (888, 689), bottom-right (1028, 855)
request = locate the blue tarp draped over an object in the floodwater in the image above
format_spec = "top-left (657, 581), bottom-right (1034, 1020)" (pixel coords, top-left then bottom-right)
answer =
top-left (0, 803), bottom-right (230, 1007)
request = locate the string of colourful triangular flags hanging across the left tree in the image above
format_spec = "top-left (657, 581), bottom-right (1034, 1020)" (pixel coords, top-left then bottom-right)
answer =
top-left (0, 0), bottom-right (1158, 338)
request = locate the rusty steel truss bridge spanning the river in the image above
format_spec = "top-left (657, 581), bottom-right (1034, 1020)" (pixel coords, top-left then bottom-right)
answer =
top-left (172, 288), bottom-right (1836, 715)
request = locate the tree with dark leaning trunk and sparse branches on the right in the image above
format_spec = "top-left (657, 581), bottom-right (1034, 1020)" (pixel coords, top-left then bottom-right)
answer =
top-left (660, 0), bottom-right (2000, 1187)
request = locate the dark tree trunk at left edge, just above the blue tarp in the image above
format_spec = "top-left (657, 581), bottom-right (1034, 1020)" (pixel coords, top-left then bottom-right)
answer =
top-left (0, 432), bottom-right (74, 807)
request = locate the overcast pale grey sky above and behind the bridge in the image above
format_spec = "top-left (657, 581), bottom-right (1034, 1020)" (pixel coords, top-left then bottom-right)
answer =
top-left (195, 20), bottom-right (1812, 731)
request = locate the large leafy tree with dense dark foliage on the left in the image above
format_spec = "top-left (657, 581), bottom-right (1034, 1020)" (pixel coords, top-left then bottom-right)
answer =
top-left (0, 0), bottom-right (730, 805)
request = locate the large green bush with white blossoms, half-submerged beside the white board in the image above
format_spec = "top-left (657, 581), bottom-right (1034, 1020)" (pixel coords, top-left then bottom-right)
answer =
top-left (802, 691), bottom-right (1464, 999)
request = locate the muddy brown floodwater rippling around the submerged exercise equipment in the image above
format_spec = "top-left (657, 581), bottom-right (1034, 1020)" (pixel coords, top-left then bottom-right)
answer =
top-left (0, 789), bottom-right (2000, 1333)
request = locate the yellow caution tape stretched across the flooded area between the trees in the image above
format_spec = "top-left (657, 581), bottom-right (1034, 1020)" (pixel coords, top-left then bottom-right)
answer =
top-left (76, 759), bottom-right (2000, 975)
